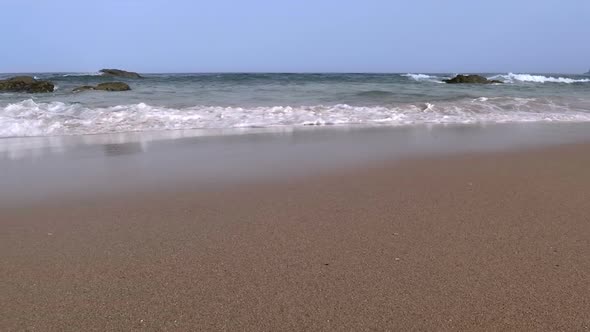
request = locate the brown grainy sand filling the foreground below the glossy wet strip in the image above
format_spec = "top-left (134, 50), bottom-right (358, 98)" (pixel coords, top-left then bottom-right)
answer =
top-left (0, 144), bottom-right (590, 331)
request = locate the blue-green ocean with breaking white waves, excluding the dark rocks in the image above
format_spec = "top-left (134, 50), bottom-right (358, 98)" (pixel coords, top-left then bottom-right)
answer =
top-left (0, 73), bottom-right (590, 138)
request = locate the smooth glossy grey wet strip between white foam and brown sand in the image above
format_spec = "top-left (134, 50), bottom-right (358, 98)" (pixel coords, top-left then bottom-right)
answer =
top-left (0, 123), bottom-right (590, 207)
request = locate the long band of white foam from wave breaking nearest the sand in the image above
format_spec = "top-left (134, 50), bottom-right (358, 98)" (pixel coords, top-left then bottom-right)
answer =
top-left (0, 97), bottom-right (590, 137)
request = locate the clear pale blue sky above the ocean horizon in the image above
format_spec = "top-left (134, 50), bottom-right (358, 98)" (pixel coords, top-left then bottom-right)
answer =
top-left (0, 0), bottom-right (590, 73)
